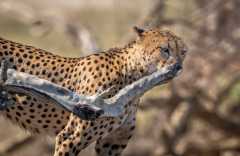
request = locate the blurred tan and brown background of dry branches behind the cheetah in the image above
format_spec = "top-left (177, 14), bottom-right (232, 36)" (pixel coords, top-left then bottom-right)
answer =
top-left (0, 0), bottom-right (240, 156)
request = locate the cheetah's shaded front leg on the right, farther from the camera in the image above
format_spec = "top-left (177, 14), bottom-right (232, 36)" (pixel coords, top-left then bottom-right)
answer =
top-left (95, 111), bottom-right (135, 156)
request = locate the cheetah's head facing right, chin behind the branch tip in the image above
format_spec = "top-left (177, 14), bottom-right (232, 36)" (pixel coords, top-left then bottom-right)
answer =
top-left (134, 27), bottom-right (187, 77)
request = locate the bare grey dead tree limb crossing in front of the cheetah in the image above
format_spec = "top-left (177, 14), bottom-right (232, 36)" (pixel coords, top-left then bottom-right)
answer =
top-left (0, 63), bottom-right (178, 120)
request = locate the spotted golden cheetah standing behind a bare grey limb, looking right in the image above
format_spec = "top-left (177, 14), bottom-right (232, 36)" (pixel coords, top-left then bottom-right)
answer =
top-left (0, 27), bottom-right (187, 156)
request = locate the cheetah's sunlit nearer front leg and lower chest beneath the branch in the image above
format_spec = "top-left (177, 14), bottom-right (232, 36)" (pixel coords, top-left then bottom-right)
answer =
top-left (54, 114), bottom-right (121, 156)
